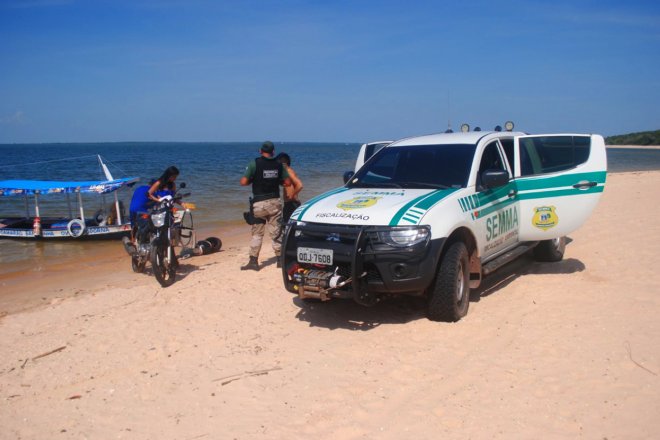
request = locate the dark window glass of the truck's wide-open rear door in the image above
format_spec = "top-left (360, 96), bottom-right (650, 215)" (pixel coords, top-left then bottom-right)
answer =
top-left (520, 136), bottom-right (591, 176)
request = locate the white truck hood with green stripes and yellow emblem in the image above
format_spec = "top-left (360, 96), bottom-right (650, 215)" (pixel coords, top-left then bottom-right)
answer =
top-left (291, 187), bottom-right (456, 226)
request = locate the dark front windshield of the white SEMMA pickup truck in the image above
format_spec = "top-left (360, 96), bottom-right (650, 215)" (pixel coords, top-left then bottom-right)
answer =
top-left (348, 144), bottom-right (476, 188)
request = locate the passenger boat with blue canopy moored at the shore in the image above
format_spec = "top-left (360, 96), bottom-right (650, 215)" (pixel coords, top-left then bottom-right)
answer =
top-left (0, 156), bottom-right (140, 239)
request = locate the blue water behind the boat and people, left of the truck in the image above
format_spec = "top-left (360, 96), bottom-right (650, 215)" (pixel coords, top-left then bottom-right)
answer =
top-left (0, 142), bottom-right (360, 225)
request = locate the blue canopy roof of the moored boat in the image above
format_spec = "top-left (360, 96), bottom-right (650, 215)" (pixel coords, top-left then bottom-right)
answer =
top-left (0, 177), bottom-right (140, 196)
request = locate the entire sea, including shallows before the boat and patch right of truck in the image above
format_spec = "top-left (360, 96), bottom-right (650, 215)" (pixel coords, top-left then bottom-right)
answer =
top-left (0, 142), bottom-right (660, 279)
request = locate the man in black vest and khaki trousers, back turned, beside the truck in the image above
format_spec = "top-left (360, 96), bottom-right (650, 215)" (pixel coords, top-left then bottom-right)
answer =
top-left (241, 141), bottom-right (291, 270)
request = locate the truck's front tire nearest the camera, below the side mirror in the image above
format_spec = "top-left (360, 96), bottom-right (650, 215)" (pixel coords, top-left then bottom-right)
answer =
top-left (427, 242), bottom-right (470, 322)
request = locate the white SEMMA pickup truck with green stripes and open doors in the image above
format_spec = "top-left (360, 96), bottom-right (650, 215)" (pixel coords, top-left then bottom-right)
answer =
top-left (282, 126), bottom-right (607, 321)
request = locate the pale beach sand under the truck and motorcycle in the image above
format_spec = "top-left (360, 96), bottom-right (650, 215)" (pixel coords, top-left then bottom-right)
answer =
top-left (0, 172), bottom-right (660, 440)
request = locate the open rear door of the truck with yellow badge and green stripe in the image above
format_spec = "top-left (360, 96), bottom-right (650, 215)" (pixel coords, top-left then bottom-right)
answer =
top-left (514, 134), bottom-right (607, 241)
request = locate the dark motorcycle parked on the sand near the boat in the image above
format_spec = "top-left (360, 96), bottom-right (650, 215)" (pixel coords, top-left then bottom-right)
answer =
top-left (131, 183), bottom-right (195, 287)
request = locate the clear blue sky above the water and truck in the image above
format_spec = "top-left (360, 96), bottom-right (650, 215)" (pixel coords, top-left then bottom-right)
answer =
top-left (0, 0), bottom-right (660, 143)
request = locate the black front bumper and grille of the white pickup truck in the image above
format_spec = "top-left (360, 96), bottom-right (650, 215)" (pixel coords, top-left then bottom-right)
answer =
top-left (282, 223), bottom-right (445, 305)
